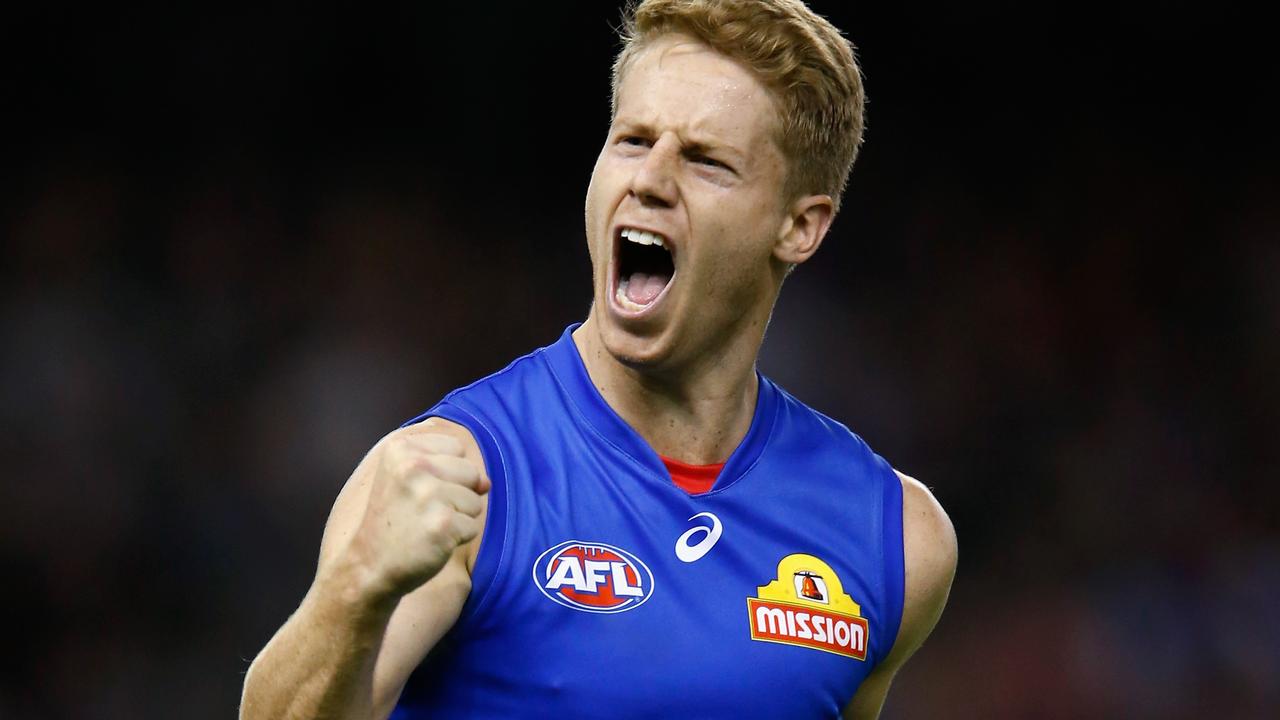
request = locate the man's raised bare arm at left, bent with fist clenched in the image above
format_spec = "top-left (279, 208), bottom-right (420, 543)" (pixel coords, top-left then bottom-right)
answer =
top-left (241, 418), bottom-right (488, 720)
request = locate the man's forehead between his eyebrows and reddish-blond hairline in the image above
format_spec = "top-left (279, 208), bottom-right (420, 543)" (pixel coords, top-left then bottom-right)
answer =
top-left (616, 35), bottom-right (778, 150)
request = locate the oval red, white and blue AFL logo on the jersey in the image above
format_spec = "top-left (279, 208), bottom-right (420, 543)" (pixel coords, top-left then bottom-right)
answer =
top-left (534, 541), bottom-right (653, 614)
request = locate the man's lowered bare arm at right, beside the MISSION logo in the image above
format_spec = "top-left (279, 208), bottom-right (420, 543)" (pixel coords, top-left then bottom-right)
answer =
top-left (844, 473), bottom-right (956, 720)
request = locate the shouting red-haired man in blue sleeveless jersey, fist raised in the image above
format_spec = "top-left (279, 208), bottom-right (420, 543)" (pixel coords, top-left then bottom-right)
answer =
top-left (241, 0), bottom-right (956, 719)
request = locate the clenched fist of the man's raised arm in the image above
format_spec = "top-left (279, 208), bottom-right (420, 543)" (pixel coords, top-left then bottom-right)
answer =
top-left (351, 430), bottom-right (489, 596)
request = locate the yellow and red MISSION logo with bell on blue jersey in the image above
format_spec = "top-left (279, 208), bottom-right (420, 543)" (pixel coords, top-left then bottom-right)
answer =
top-left (746, 553), bottom-right (868, 660)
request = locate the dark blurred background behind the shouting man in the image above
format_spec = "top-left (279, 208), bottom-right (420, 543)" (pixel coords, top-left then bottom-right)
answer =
top-left (0, 1), bottom-right (1280, 720)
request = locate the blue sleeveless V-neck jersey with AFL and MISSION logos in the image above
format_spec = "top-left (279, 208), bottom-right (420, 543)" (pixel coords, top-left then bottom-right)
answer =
top-left (392, 327), bottom-right (904, 720)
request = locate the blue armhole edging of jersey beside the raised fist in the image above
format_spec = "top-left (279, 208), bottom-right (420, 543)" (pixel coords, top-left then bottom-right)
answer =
top-left (404, 400), bottom-right (511, 626)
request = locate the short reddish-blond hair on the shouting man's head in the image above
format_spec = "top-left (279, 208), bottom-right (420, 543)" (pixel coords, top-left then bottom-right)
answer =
top-left (612, 0), bottom-right (865, 209)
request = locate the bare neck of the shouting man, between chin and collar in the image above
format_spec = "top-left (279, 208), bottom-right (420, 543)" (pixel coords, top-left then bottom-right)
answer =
top-left (573, 309), bottom-right (764, 465)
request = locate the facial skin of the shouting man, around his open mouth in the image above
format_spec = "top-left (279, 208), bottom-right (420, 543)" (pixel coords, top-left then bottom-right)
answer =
top-left (584, 36), bottom-right (787, 377)
